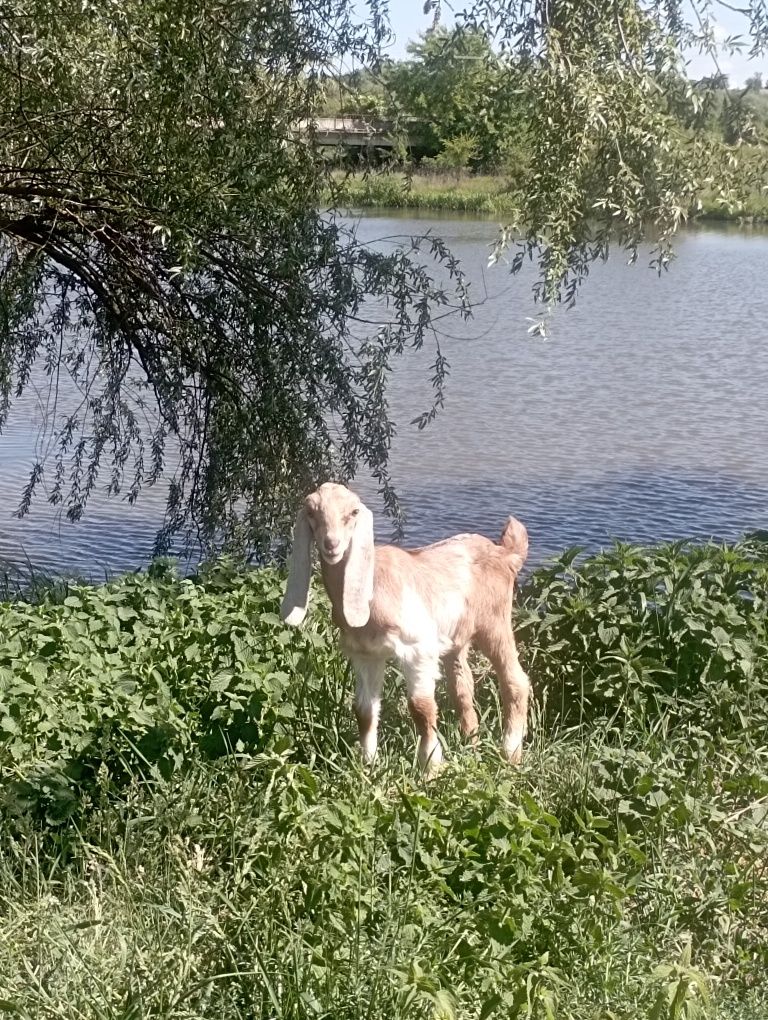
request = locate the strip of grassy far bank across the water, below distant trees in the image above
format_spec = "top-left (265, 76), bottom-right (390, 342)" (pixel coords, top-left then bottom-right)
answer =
top-left (330, 173), bottom-right (768, 223)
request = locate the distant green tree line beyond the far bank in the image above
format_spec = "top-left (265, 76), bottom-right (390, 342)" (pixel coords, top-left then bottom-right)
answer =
top-left (322, 27), bottom-right (768, 173)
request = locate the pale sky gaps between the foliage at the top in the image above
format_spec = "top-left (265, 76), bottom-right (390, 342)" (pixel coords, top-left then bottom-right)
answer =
top-left (388, 0), bottom-right (768, 86)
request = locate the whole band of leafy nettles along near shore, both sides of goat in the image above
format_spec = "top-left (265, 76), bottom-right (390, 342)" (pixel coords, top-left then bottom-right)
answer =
top-left (0, 543), bottom-right (768, 829)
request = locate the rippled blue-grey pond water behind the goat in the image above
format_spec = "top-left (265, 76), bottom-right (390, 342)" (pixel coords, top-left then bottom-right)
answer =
top-left (0, 214), bottom-right (768, 576)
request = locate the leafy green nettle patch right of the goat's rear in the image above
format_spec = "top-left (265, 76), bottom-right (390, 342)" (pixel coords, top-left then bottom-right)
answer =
top-left (516, 541), bottom-right (768, 740)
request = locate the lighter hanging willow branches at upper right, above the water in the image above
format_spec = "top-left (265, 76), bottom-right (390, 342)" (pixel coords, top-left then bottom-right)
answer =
top-left (460, 0), bottom-right (768, 302)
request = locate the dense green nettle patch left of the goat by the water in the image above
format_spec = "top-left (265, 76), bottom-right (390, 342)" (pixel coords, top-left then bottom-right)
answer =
top-left (0, 561), bottom-right (352, 819)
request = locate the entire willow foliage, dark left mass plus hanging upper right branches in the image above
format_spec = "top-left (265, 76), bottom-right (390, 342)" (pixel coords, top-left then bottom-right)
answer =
top-left (0, 0), bottom-right (766, 547)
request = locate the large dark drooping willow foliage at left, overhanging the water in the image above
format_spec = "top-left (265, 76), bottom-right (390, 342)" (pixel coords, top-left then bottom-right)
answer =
top-left (0, 0), bottom-right (466, 548)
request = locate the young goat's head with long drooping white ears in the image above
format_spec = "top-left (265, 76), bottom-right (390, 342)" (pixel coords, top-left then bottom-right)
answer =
top-left (281, 481), bottom-right (373, 627)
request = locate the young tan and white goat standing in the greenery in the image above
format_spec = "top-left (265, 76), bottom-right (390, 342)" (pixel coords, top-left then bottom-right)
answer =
top-left (280, 481), bottom-right (530, 770)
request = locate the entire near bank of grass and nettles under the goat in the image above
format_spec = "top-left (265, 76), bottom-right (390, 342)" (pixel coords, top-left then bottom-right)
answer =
top-left (0, 543), bottom-right (768, 1020)
